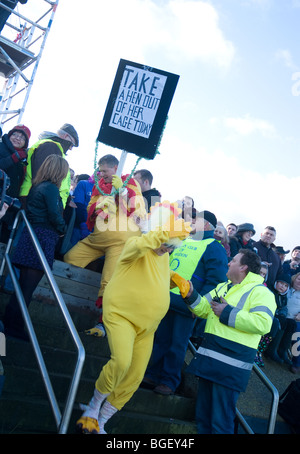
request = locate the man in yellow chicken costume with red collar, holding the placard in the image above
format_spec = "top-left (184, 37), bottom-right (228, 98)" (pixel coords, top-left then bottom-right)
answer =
top-left (64, 154), bottom-right (147, 337)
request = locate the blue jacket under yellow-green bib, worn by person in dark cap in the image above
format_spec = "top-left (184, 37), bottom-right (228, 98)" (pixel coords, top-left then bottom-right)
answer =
top-left (170, 230), bottom-right (228, 318)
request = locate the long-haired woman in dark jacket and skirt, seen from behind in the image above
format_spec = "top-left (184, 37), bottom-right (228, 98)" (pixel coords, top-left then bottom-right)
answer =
top-left (4, 155), bottom-right (69, 340)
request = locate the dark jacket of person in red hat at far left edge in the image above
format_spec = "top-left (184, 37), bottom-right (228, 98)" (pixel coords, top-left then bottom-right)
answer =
top-left (0, 134), bottom-right (25, 197)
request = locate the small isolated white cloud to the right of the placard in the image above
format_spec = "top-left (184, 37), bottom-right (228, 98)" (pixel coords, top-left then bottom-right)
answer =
top-left (224, 115), bottom-right (276, 137)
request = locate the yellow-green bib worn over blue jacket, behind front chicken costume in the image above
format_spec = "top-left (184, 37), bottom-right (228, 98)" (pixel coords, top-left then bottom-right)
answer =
top-left (170, 238), bottom-right (216, 295)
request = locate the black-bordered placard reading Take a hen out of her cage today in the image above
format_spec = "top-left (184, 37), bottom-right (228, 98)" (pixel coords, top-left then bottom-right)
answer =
top-left (97, 60), bottom-right (179, 159)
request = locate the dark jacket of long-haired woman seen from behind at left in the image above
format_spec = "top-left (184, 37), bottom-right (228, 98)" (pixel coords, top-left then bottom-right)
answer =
top-left (26, 181), bottom-right (66, 235)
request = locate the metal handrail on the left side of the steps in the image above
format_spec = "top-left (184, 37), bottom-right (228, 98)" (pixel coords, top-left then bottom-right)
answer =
top-left (1, 210), bottom-right (85, 434)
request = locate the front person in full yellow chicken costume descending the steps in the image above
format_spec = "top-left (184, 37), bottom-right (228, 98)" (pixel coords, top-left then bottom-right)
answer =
top-left (76, 202), bottom-right (191, 434)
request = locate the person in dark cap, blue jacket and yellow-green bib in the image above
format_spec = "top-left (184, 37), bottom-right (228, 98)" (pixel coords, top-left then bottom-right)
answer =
top-left (143, 211), bottom-right (228, 395)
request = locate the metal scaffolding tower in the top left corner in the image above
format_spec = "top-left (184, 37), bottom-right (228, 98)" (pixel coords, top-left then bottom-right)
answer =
top-left (0, 0), bottom-right (58, 128)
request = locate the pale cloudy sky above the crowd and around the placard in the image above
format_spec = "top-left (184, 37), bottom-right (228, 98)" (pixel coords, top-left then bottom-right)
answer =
top-left (4, 0), bottom-right (300, 255)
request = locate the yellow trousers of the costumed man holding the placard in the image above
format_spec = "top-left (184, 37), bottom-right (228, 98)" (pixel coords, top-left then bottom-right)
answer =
top-left (64, 219), bottom-right (141, 296)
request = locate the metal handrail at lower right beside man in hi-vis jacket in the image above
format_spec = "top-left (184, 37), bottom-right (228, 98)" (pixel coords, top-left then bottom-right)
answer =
top-left (189, 341), bottom-right (279, 434)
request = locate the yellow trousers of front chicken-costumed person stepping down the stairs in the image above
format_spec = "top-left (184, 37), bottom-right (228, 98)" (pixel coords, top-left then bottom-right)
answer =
top-left (96, 312), bottom-right (157, 410)
